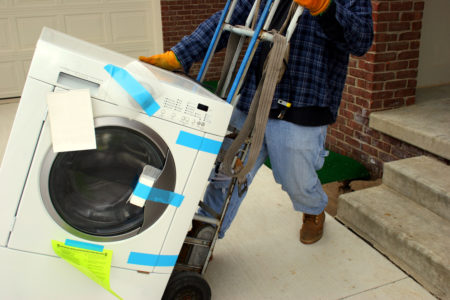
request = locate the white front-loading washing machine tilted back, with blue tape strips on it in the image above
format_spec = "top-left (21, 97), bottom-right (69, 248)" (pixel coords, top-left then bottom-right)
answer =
top-left (0, 28), bottom-right (232, 299)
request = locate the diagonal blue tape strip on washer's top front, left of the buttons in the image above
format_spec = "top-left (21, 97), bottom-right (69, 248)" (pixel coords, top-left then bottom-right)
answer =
top-left (105, 64), bottom-right (160, 116)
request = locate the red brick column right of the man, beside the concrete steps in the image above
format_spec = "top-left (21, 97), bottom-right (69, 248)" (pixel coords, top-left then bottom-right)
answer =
top-left (327, 0), bottom-right (424, 176)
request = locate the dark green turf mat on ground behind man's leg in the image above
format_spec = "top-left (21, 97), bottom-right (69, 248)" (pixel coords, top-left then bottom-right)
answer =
top-left (265, 151), bottom-right (370, 184)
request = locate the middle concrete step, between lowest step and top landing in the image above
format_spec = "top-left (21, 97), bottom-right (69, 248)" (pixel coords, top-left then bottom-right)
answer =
top-left (383, 156), bottom-right (450, 221)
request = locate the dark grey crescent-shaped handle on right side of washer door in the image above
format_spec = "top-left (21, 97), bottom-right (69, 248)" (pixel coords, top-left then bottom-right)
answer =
top-left (139, 149), bottom-right (176, 232)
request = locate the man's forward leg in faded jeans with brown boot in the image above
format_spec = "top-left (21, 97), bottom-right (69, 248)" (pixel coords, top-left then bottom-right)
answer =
top-left (266, 120), bottom-right (328, 244)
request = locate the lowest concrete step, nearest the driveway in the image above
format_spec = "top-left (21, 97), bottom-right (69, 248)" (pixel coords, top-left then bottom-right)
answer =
top-left (337, 184), bottom-right (450, 299)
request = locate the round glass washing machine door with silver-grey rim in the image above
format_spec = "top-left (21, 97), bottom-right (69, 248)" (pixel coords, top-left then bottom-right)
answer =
top-left (41, 117), bottom-right (176, 241)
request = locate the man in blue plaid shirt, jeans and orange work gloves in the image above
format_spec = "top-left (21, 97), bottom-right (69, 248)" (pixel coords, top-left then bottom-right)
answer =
top-left (140, 0), bottom-right (373, 244)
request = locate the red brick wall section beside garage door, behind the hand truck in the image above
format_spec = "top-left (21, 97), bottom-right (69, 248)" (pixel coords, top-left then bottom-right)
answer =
top-left (161, 0), bottom-right (226, 80)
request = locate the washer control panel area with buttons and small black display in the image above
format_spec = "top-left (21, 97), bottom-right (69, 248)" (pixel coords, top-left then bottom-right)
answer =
top-left (155, 97), bottom-right (214, 130)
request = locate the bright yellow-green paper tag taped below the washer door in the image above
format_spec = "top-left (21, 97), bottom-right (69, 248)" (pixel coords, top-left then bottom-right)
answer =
top-left (52, 241), bottom-right (122, 299)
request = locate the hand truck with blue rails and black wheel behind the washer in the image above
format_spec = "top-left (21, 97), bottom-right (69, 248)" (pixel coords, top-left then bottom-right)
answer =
top-left (163, 0), bottom-right (303, 299)
